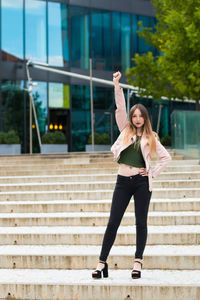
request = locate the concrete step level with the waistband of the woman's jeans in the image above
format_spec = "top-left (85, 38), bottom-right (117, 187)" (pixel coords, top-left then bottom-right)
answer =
top-left (0, 171), bottom-right (200, 184)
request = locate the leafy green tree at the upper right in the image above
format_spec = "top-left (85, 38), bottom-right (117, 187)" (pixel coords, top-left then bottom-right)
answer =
top-left (126, 0), bottom-right (200, 110)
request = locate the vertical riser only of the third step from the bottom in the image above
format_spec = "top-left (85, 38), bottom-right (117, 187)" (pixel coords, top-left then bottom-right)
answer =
top-left (0, 233), bottom-right (200, 246)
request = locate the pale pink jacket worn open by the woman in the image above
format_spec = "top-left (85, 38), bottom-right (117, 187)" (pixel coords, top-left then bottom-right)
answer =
top-left (111, 87), bottom-right (172, 191)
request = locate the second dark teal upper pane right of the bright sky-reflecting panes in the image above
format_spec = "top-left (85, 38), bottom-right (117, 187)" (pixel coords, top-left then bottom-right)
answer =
top-left (92, 10), bottom-right (112, 70)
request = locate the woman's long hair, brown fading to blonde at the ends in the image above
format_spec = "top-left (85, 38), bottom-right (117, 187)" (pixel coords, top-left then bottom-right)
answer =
top-left (123, 103), bottom-right (159, 156)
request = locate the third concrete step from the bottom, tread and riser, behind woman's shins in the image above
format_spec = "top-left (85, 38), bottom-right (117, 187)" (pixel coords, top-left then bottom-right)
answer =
top-left (0, 225), bottom-right (200, 246)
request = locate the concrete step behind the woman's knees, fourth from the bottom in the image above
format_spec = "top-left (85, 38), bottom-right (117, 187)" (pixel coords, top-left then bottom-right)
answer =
top-left (0, 211), bottom-right (200, 227)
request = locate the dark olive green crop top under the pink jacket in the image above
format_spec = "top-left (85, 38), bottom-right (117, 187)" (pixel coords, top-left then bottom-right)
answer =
top-left (117, 136), bottom-right (145, 168)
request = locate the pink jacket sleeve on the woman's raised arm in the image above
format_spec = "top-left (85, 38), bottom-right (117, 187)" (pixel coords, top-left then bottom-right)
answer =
top-left (115, 87), bottom-right (129, 132)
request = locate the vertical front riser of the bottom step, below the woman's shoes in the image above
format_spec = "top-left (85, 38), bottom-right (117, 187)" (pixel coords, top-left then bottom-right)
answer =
top-left (0, 282), bottom-right (200, 300)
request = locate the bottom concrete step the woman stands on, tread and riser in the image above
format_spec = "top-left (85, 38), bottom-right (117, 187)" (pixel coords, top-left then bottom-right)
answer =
top-left (0, 270), bottom-right (200, 300)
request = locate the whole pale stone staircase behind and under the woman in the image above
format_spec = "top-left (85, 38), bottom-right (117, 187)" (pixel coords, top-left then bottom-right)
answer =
top-left (0, 150), bottom-right (200, 300)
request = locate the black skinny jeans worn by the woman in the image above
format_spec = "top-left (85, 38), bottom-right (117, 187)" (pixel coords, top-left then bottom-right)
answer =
top-left (99, 174), bottom-right (152, 261)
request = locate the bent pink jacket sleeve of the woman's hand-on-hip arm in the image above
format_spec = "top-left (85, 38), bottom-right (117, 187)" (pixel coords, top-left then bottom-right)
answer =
top-left (151, 137), bottom-right (172, 178)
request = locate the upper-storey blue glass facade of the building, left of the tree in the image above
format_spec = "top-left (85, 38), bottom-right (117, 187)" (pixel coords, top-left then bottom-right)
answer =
top-left (1, 0), bottom-right (155, 68)
